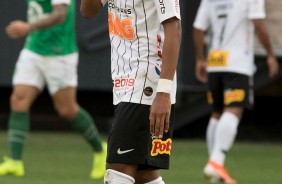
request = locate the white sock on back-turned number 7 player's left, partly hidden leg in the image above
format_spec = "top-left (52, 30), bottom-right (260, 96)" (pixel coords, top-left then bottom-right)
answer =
top-left (206, 117), bottom-right (218, 155)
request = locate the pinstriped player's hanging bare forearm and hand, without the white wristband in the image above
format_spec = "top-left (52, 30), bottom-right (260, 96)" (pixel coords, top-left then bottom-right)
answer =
top-left (150, 17), bottom-right (181, 138)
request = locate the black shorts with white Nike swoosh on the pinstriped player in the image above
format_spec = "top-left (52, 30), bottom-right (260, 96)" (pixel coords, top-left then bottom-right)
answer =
top-left (107, 102), bottom-right (174, 169)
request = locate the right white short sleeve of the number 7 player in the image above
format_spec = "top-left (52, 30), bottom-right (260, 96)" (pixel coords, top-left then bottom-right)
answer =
top-left (248, 0), bottom-right (266, 19)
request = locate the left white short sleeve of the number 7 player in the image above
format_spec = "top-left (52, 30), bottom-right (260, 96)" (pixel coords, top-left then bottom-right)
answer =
top-left (193, 0), bottom-right (210, 31)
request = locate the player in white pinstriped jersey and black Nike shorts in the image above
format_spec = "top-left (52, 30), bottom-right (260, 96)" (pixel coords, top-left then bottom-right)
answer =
top-left (81, 0), bottom-right (181, 184)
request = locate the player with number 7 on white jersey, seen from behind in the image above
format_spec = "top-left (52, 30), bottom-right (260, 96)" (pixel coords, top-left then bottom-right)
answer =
top-left (194, 0), bottom-right (278, 184)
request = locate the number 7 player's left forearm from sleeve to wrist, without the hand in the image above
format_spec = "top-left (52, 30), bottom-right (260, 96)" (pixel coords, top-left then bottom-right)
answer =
top-left (193, 28), bottom-right (205, 61)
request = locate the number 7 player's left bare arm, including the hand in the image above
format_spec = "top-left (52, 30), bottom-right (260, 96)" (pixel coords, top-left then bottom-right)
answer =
top-left (193, 28), bottom-right (207, 83)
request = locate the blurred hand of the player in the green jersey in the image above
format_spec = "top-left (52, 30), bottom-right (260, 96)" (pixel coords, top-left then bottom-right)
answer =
top-left (6, 20), bottom-right (31, 39)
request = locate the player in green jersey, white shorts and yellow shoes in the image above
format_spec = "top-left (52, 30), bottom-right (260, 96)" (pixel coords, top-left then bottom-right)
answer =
top-left (0, 0), bottom-right (107, 179)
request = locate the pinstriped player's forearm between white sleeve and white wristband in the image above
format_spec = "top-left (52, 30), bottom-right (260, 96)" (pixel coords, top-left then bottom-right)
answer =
top-left (160, 18), bottom-right (181, 80)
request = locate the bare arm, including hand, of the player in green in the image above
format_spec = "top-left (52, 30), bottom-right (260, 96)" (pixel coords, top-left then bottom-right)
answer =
top-left (6, 4), bottom-right (67, 39)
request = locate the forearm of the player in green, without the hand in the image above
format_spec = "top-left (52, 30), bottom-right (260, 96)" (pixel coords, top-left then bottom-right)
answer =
top-left (30, 5), bottom-right (67, 31)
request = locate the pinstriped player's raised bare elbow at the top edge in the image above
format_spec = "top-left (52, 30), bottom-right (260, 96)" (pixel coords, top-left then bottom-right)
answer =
top-left (80, 0), bottom-right (103, 19)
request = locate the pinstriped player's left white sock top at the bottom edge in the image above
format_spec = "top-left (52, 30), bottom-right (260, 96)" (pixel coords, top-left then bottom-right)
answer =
top-left (104, 169), bottom-right (135, 184)
